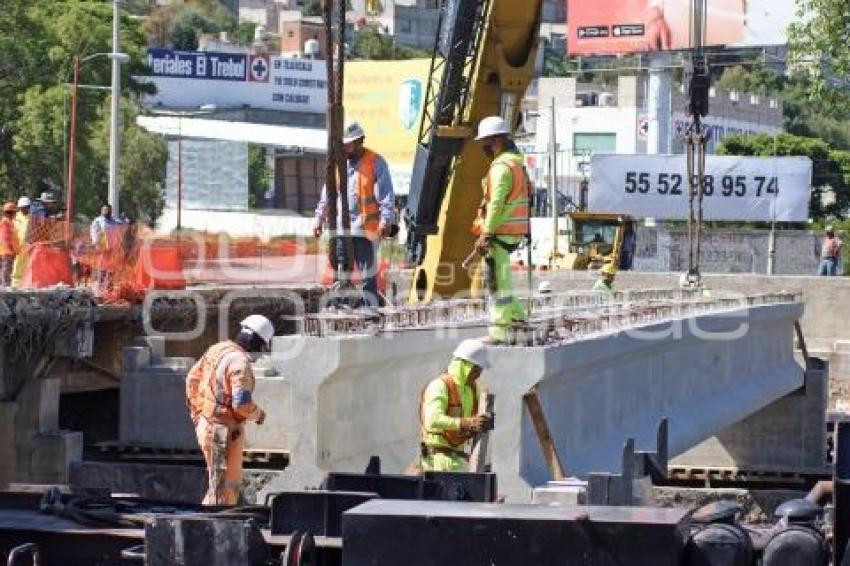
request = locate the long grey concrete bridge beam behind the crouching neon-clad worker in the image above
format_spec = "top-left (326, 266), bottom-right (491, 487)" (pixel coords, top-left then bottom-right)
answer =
top-left (260, 303), bottom-right (803, 501)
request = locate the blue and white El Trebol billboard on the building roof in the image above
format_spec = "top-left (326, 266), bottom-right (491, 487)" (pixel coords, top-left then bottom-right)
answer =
top-left (144, 49), bottom-right (327, 114)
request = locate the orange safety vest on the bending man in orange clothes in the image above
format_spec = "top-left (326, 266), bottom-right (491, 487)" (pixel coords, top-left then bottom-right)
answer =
top-left (190, 341), bottom-right (247, 424)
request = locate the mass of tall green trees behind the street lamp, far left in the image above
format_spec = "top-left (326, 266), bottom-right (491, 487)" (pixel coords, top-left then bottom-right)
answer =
top-left (0, 0), bottom-right (164, 222)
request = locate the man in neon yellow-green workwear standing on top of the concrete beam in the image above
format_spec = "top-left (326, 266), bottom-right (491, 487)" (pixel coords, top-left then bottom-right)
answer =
top-left (473, 116), bottom-right (531, 343)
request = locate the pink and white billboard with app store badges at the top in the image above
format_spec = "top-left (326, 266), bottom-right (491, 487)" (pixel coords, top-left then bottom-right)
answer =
top-left (566, 0), bottom-right (795, 55)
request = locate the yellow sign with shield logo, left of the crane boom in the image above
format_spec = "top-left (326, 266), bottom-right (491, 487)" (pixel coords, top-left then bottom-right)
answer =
top-left (344, 59), bottom-right (431, 194)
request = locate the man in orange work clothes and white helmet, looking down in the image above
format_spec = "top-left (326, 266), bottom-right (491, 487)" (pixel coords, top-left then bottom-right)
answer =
top-left (186, 314), bottom-right (274, 505)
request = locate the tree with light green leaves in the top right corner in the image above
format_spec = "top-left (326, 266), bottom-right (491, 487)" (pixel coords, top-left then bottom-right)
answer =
top-left (788, 0), bottom-right (850, 111)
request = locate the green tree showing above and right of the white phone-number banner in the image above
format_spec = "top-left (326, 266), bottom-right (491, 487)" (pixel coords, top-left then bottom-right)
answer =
top-left (717, 134), bottom-right (850, 220)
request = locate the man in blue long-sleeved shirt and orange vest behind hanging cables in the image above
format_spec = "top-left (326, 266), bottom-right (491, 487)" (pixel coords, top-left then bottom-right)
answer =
top-left (313, 122), bottom-right (395, 308)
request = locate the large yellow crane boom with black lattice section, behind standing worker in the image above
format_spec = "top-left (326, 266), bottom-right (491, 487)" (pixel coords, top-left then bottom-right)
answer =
top-left (404, 0), bottom-right (543, 302)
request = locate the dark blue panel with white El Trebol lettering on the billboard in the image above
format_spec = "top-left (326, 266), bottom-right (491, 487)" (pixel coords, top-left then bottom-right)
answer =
top-left (147, 49), bottom-right (248, 81)
